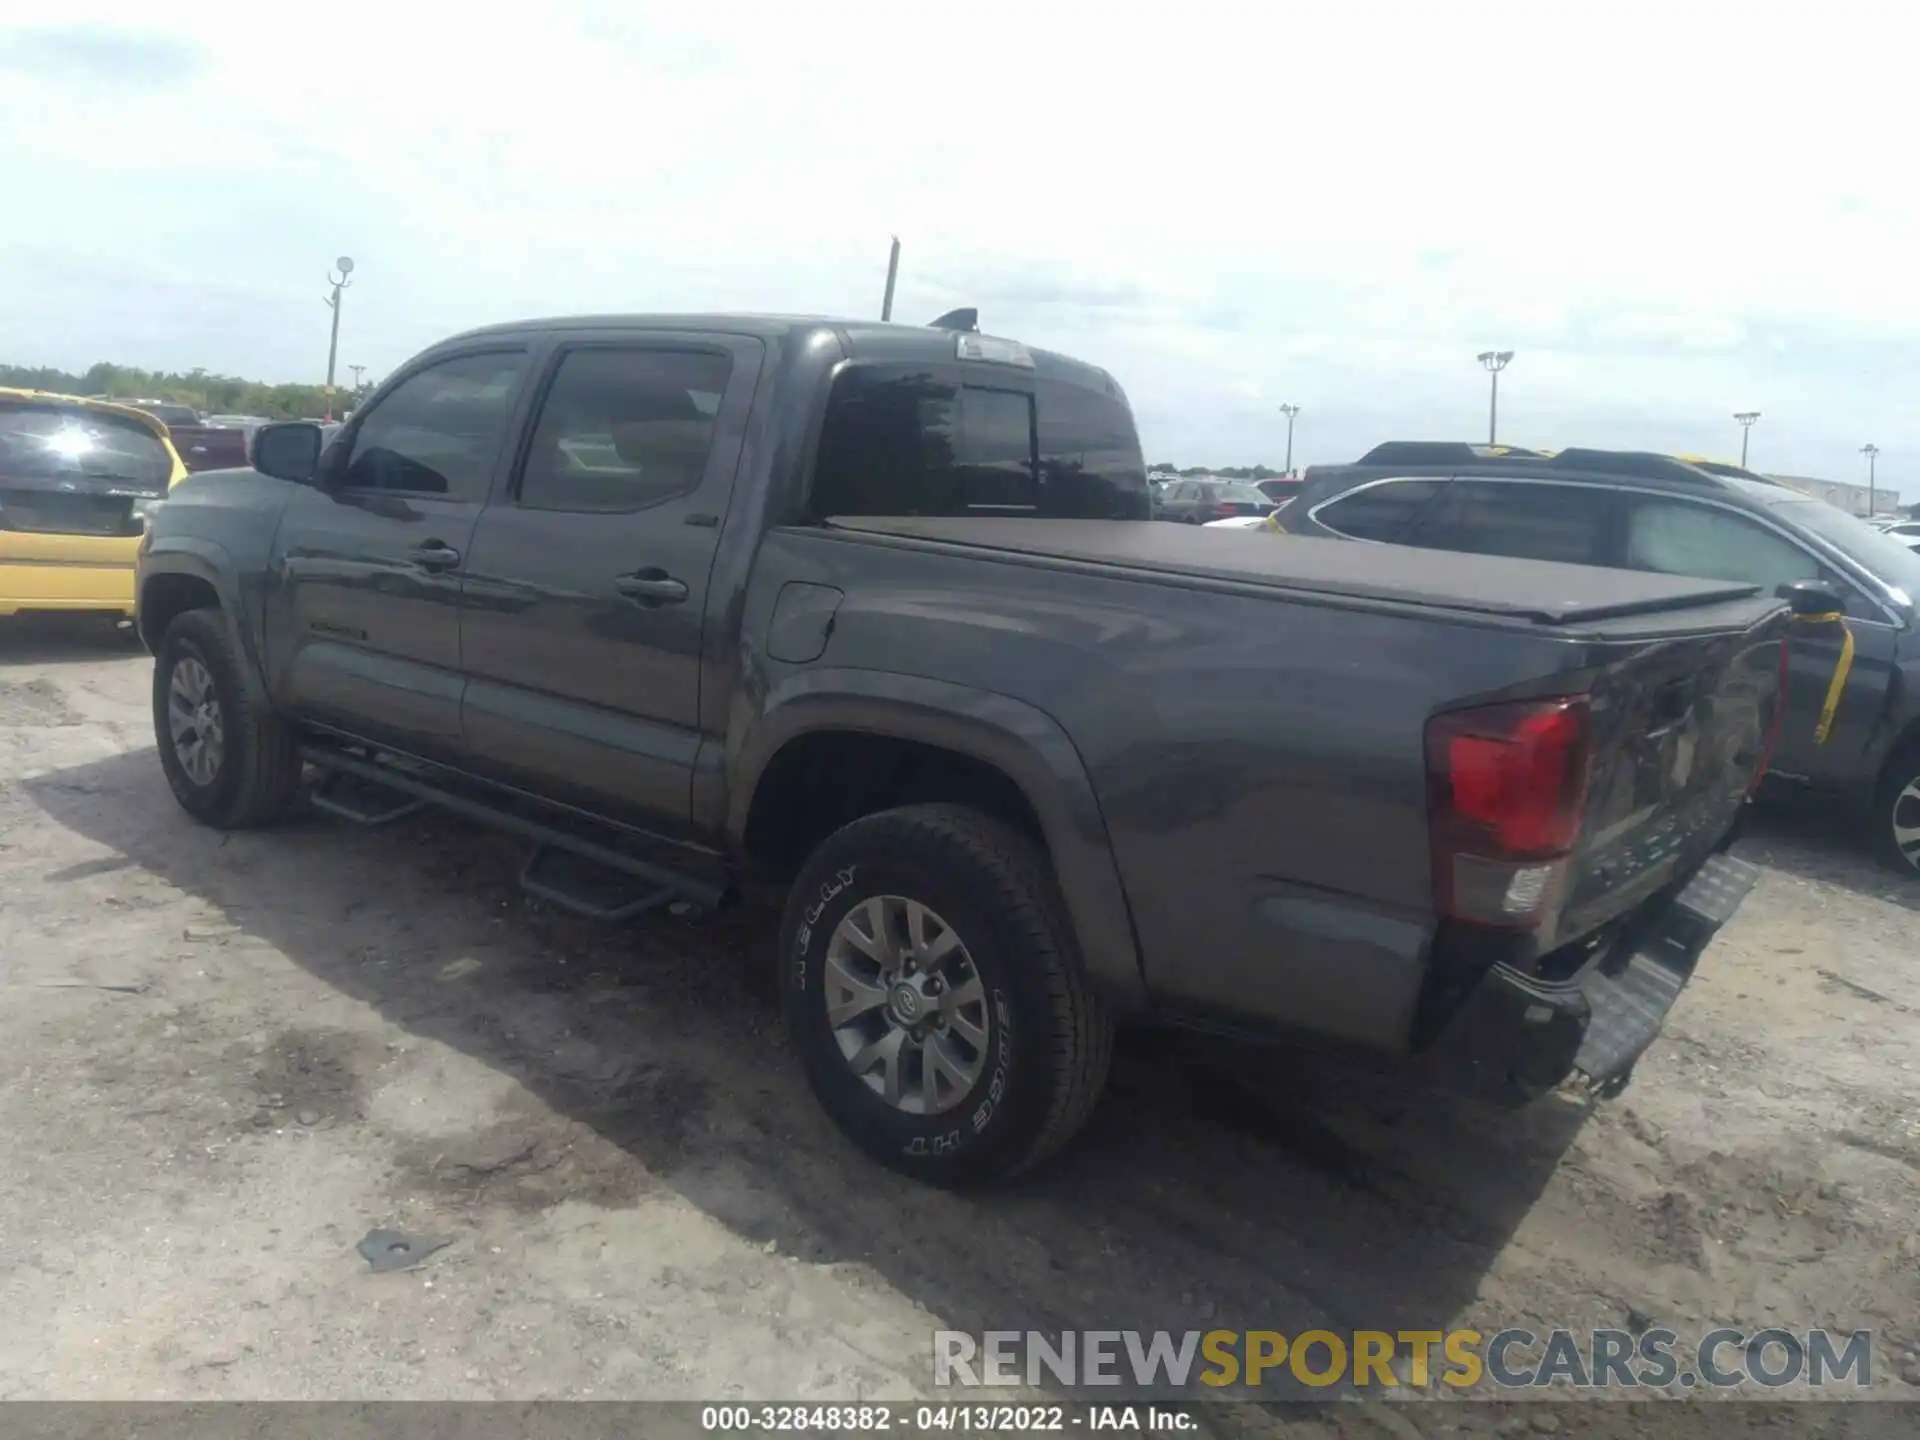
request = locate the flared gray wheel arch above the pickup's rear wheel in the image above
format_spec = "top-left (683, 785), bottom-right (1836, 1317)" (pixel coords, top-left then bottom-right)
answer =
top-left (728, 672), bottom-right (1146, 1012)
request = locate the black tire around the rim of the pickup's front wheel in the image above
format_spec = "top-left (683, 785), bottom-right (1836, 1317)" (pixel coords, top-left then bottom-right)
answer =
top-left (154, 609), bottom-right (300, 829)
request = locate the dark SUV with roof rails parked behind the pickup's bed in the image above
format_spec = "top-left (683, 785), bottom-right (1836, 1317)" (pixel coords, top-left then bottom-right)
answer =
top-left (1281, 442), bottom-right (1920, 874)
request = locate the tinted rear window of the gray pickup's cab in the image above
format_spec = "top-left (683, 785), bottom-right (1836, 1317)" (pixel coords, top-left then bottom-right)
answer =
top-left (810, 367), bottom-right (1148, 520)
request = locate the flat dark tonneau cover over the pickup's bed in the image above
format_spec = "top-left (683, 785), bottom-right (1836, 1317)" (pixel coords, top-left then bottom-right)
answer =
top-left (828, 516), bottom-right (1759, 626)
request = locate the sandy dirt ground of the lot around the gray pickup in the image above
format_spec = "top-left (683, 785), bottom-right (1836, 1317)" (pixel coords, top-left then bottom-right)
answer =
top-left (0, 626), bottom-right (1920, 1434)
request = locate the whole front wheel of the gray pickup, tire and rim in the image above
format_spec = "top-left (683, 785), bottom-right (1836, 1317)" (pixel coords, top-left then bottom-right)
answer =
top-left (154, 611), bottom-right (300, 829)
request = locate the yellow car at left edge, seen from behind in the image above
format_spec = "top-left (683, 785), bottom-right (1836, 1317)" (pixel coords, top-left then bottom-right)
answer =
top-left (0, 386), bottom-right (186, 616)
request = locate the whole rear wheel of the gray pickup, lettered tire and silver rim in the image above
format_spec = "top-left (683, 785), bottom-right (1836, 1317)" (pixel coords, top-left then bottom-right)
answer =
top-left (780, 804), bottom-right (1114, 1185)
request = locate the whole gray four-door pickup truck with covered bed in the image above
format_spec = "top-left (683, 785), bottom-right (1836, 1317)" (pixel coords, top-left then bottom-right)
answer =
top-left (138, 315), bottom-right (1789, 1183)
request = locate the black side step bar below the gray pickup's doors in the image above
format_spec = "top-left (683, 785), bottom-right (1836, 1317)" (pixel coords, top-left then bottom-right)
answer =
top-left (301, 745), bottom-right (726, 920)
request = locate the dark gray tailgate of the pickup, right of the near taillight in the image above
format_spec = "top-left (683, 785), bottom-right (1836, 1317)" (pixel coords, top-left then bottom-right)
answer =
top-left (1557, 611), bottom-right (1788, 941)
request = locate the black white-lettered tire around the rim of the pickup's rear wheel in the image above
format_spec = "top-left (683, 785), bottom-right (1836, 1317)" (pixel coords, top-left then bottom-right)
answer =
top-left (780, 804), bottom-right (1114, 1185)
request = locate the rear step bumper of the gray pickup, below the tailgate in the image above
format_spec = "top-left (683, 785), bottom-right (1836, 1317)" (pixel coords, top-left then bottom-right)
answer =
top-left (1421, 854), bottom-right (1761, 1104)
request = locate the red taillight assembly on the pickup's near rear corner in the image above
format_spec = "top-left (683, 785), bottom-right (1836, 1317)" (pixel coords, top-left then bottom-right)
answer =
top-left (1427, 695), bottom-right (1592, 927)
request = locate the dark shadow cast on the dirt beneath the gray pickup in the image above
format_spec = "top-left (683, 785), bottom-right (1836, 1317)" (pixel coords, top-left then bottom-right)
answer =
top-left (25, 749), bottom-right (1586, 1382)
